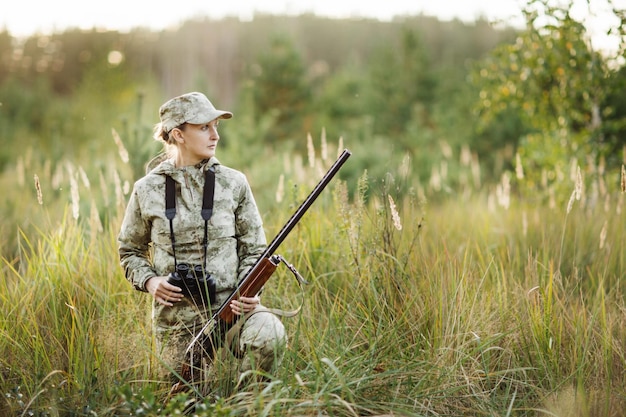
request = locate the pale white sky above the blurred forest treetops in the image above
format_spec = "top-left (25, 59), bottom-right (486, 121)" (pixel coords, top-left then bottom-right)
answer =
top-left (0, 0), bottom-right (626, 53)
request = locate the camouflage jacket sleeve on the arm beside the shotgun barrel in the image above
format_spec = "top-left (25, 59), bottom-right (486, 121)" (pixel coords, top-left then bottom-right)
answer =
top-left (235, 176), bottom-right (267, 281)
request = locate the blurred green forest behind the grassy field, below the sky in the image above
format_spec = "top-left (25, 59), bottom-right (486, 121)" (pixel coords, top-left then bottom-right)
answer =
top-left (0, 1), bottom-right (626, 250)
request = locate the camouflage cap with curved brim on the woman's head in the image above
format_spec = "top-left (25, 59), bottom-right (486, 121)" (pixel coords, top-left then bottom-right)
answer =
top-left (159, 92), bottom-right (233, 132)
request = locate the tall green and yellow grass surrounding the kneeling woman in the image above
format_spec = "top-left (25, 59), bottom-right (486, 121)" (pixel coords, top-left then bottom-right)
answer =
top-left (0, 136), bottom-right (626, 416)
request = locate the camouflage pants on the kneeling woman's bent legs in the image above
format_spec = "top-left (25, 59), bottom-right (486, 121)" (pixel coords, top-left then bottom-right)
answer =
top-left (155, 307), bottom-right (287, 395)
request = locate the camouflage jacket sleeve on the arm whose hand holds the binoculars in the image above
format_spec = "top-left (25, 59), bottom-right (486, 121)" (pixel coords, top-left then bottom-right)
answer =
top-left (118, 189), bottom-right (157, 291)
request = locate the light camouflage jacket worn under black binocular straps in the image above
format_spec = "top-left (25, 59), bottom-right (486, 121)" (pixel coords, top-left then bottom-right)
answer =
top-left (118, 157), bottom-right (267, 324)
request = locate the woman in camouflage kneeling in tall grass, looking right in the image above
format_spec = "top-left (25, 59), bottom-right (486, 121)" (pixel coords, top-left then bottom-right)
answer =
top-left (118, 92), bottom-right (286, 394)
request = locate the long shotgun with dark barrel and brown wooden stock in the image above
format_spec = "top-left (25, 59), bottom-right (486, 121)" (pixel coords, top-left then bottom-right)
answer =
top-left (186, 149), bottom-right (351, 354)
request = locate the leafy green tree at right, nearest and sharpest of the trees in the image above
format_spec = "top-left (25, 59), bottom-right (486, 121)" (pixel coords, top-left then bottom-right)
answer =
top-left (473, 0), bottom-right (612, 197)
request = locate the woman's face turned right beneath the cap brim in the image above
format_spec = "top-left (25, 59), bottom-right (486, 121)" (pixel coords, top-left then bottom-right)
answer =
top-left (172, 119), bottom-right (220, 167)
